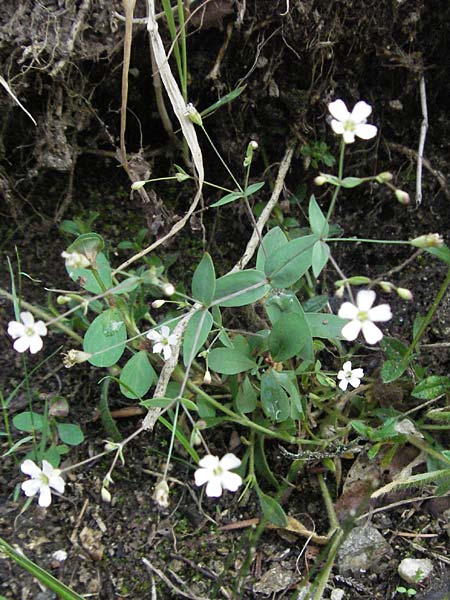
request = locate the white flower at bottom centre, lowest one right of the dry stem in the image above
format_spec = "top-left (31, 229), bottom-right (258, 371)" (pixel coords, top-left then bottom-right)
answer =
top-left (194, 453), bottom-right (242, 498)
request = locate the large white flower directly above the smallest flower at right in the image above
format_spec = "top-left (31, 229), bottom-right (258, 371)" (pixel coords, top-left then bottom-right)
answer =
top-left (338, 290), bottom-right (392, 344)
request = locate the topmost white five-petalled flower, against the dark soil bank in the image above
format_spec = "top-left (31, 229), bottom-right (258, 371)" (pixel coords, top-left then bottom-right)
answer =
top-left (328, 100), bottom-right (377, 144)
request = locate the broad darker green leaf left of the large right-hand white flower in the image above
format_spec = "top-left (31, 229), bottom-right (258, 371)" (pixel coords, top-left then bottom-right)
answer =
top-left (269, 313), bottom-right (314, 361)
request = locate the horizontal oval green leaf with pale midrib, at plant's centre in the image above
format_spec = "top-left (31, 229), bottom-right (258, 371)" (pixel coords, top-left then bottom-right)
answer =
top-left (214, 269), bottom-right (269, 307)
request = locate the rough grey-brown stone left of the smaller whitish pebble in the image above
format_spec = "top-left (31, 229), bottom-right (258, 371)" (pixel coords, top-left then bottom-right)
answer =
top-left (337, 527), bottom-right (391, 576)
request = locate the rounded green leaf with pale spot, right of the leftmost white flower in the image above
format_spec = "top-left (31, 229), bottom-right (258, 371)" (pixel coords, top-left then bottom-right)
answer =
top-left (83, 308), bottom-right (127, 367)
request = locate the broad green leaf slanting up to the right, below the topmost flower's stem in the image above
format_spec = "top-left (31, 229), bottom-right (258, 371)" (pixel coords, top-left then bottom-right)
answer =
top-left (264, 235), bottom-right (317, 288)
